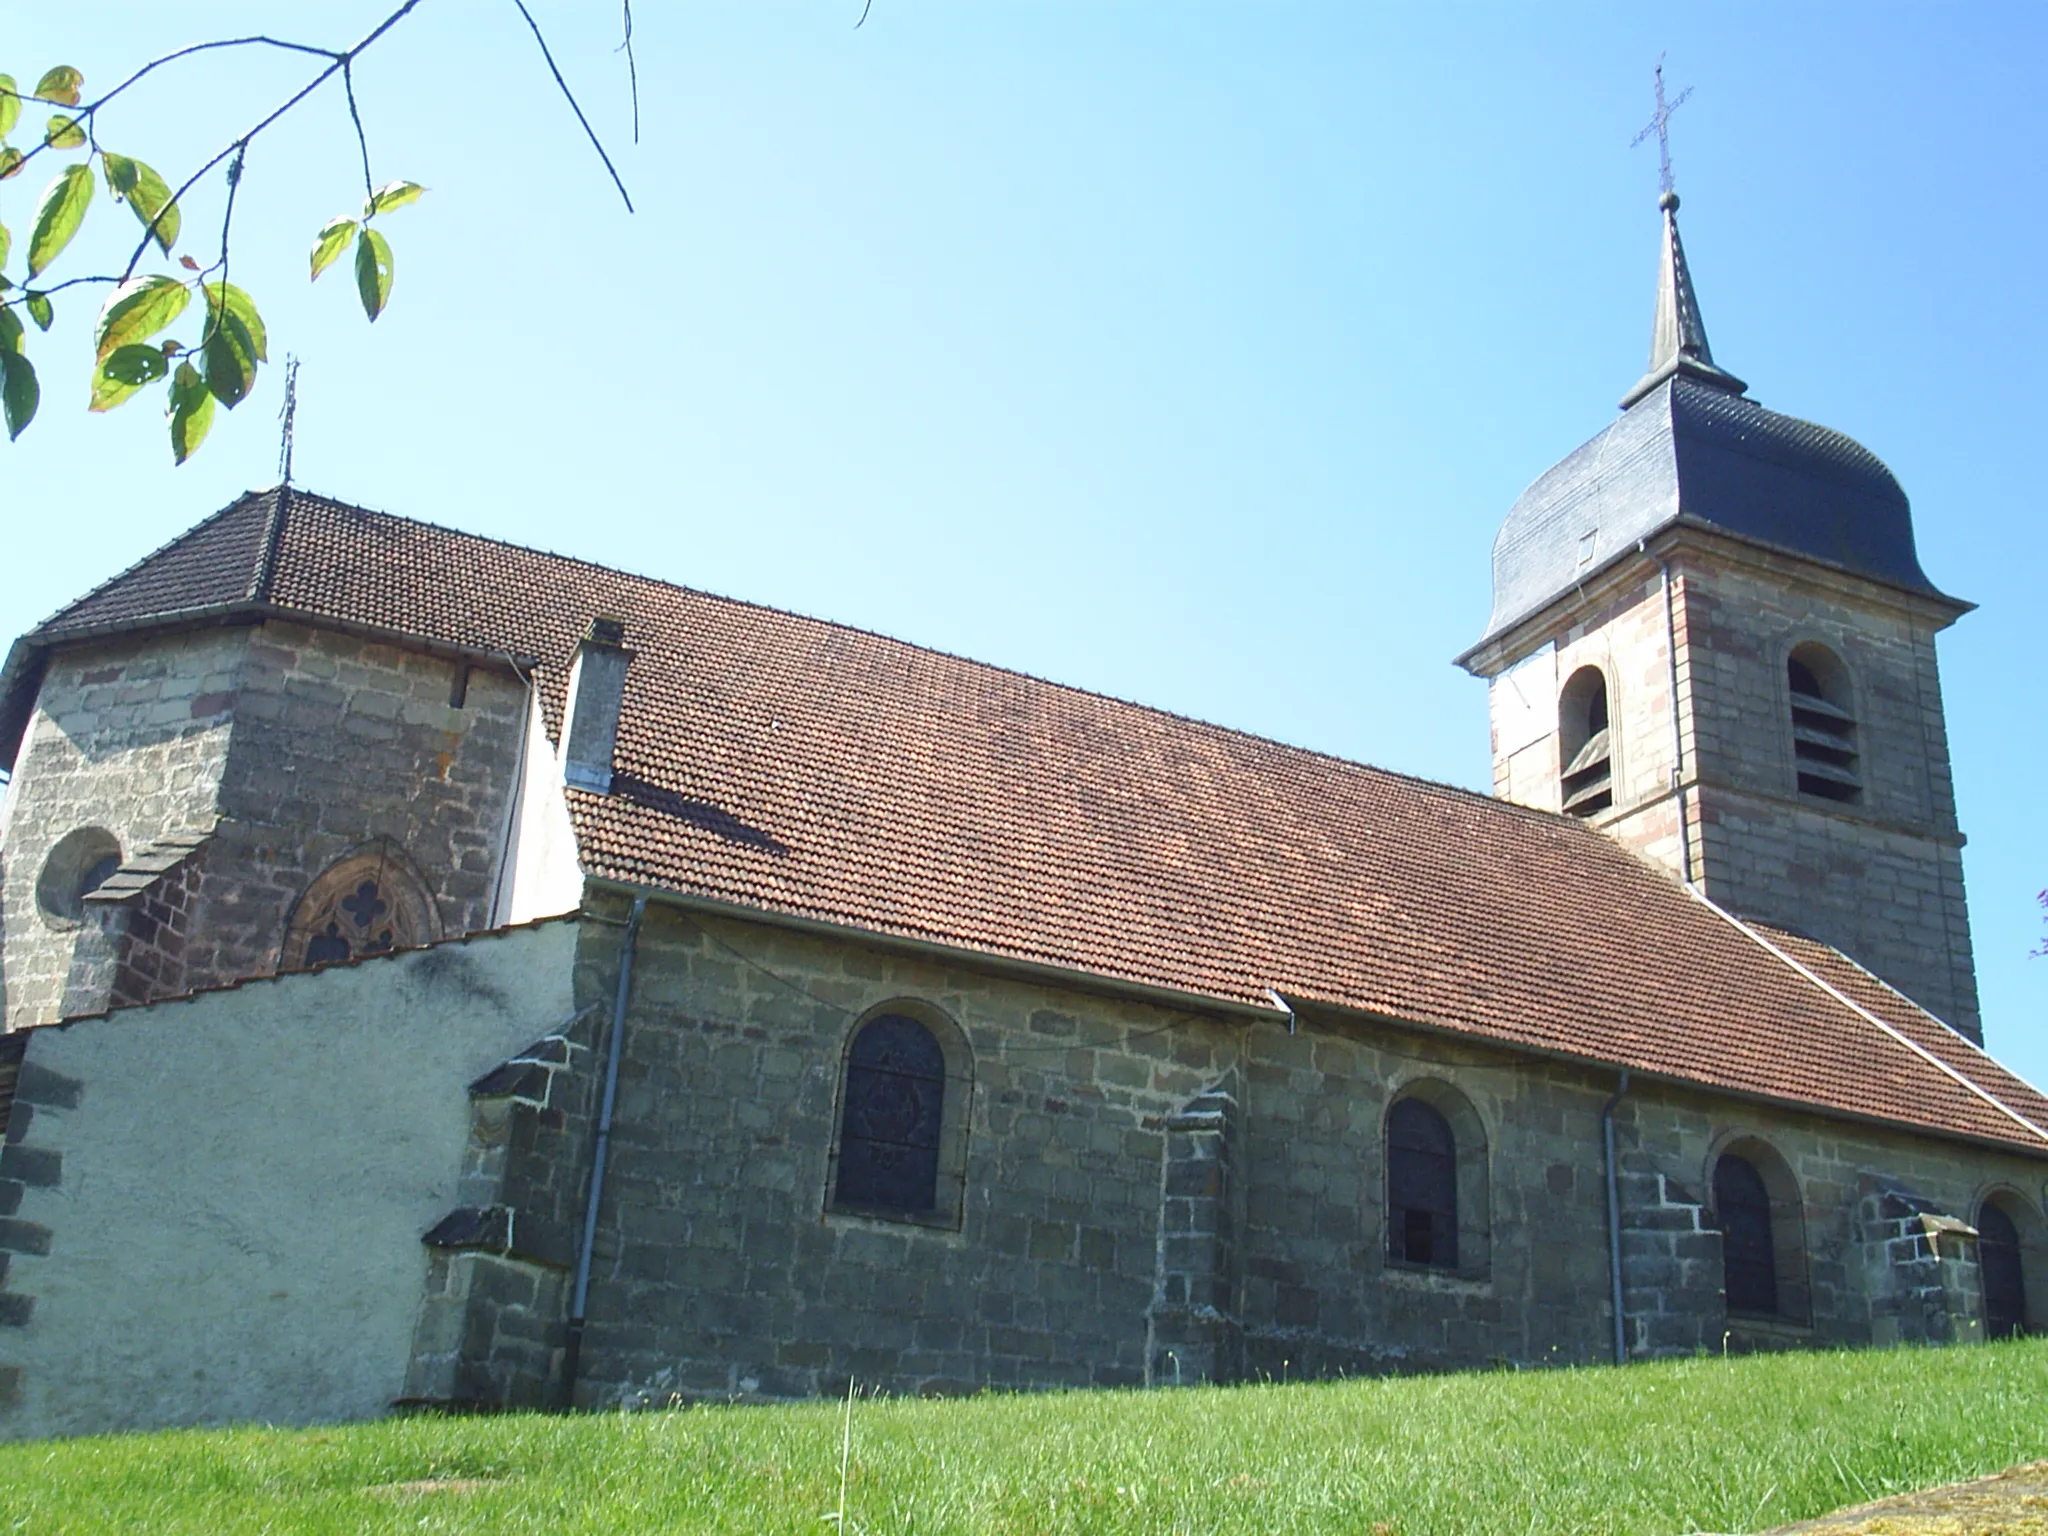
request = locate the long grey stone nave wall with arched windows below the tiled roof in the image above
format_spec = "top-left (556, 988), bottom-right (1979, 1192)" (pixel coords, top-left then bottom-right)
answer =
top-left (464, 888), bottom-right (2048, 1407)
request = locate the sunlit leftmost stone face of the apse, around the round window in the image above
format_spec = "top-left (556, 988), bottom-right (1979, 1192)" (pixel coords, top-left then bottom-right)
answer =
top-left (0, 629), bottom-right (248, 1028)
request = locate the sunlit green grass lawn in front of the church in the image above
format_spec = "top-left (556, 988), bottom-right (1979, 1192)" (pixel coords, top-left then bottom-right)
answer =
top-left (0, 1341), bottom-right (2048, 1536)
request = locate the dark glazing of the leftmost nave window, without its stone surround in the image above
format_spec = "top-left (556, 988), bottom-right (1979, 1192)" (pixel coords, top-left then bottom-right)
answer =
top-left (834, 1014), bottom-right (946, 1214)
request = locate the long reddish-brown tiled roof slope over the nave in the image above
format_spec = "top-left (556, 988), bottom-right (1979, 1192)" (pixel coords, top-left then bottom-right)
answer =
top-left (16, 492), bottom-right (2048, 1151)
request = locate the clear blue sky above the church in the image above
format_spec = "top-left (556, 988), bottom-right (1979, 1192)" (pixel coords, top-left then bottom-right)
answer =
top-left (0, 0), bottom-right (2048, 1081)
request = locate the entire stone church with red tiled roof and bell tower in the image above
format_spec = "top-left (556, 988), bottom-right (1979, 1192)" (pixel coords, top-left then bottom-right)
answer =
top-left (0, 193), bottom-right (2048, 1438)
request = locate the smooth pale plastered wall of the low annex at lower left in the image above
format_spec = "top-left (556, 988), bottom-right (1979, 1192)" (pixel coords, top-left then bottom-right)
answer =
top-left (0, 922), bottom-right (575, 1438)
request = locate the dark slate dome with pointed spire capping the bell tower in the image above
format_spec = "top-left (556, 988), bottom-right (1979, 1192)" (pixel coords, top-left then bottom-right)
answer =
top-left (1481, 193), bottom-right (1939, 643)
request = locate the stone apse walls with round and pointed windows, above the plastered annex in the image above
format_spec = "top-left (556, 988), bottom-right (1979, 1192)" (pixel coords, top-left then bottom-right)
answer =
top-left (0, 623), bottom-right (526, 1028)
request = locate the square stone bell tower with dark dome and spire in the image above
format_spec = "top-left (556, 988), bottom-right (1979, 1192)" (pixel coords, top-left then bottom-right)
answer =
top-left (1458, 190), bottom-right (1980, 1040)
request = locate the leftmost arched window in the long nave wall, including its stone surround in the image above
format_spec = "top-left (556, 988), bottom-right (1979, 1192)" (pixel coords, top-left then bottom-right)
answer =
top-left (829, 1004), bottom-right (973, 1225)
